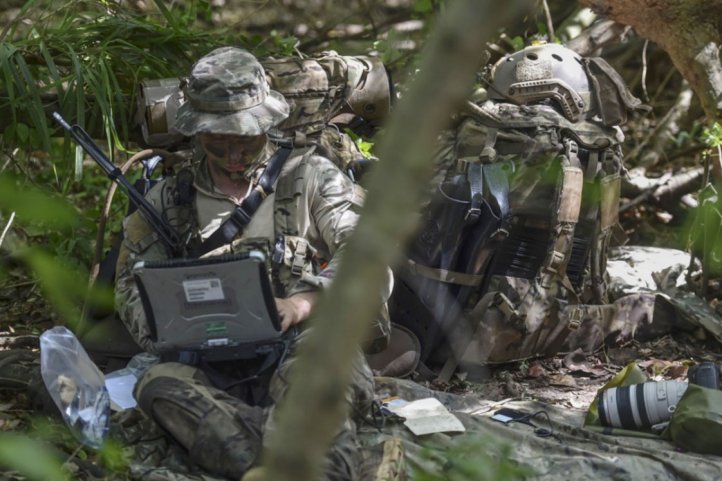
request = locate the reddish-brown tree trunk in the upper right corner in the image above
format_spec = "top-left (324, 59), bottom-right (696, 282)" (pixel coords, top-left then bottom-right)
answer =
top-left (579, 0), bottom-right (722, 119)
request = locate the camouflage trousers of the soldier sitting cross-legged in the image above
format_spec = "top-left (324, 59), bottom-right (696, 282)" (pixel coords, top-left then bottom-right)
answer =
top-left (135, 330), bottom-right (373, 481)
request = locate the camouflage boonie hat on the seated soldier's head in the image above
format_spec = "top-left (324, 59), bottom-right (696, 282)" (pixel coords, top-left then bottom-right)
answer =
top-left (173, 47), bottom-right (289, 136)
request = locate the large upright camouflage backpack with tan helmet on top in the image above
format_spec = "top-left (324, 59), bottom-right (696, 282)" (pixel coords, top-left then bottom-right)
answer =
top-left (391, 45), bottom-right (639, 376)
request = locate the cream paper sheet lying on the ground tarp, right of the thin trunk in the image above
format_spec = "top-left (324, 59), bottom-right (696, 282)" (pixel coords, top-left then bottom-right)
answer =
top-left (386, 398), bottom-right (466, 436)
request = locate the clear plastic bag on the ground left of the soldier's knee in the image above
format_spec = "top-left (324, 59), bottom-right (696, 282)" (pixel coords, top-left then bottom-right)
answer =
top-left (40, 326), bottom-right (110, 449)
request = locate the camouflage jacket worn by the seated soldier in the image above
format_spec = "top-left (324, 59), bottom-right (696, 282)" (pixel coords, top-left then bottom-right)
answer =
top-left (115, 143), bottom-right (391, 352)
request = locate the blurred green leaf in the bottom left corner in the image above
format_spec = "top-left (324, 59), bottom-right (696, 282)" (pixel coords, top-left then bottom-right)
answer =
top-left (0, 433), bottom-right (70, 481)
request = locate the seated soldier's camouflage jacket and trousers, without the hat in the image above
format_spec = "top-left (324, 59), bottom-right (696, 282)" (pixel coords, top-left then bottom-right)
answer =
top-left (116, 142), bottom-right (391, 480)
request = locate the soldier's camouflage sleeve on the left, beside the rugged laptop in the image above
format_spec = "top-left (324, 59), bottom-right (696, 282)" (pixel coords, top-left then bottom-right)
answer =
top-left (115, 202), bottom-right (168, 353)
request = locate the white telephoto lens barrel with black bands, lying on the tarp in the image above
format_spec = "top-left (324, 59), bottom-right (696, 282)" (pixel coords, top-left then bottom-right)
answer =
top-left (599, 381), bottom-right (687, 429)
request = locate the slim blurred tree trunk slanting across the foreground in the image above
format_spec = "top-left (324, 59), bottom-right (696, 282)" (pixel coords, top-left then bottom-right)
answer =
top-left (254, 0), bottom-right (529, 481)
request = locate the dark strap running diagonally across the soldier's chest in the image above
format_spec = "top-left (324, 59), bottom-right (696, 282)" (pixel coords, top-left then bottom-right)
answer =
top-left (191, 147), bottom-right (292, 257)
